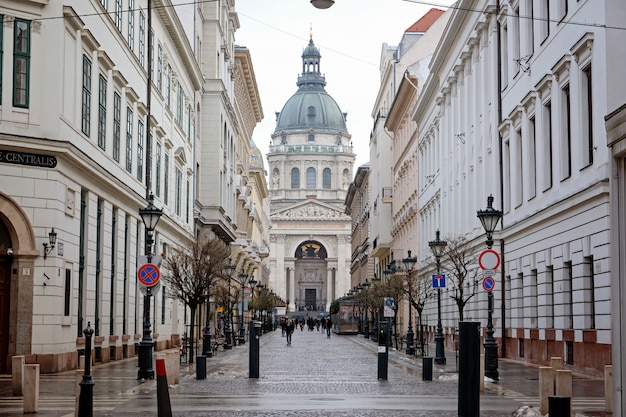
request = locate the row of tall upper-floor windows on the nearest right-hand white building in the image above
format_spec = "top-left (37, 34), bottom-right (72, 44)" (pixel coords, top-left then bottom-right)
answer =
top-left (503, 38), bottom-right (594, 211)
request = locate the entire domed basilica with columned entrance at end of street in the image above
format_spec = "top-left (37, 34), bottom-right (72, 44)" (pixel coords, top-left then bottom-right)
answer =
top-left (267, 38), bottom-right (355, 312)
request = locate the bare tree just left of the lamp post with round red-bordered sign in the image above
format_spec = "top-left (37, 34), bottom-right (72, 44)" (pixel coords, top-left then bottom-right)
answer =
top-left (443, 236), bottom-right (478, 321)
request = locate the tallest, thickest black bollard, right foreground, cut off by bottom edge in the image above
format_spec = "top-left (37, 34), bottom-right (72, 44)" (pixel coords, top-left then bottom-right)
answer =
top-left (458, 321), bottom-right (480, 417)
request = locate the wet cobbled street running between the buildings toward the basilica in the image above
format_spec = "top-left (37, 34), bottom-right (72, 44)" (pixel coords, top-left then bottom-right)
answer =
top-left (0, 329), bottom-right (603, 417)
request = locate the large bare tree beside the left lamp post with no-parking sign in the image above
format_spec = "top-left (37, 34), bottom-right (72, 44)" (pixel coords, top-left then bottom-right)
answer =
top-left (163, 239), bottom-right (230, 362)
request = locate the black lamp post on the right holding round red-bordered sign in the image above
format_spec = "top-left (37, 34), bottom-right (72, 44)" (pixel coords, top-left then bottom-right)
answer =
top-left (476, 195), bottom-right (502, 381)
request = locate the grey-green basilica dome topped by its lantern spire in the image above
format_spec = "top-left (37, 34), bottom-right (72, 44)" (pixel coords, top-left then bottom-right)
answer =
top-left (274, 38), bottom-right (348, 134)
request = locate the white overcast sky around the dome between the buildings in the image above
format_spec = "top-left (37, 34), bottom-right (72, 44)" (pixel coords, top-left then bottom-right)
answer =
top-left (235, 0), bottom-right (453, 172)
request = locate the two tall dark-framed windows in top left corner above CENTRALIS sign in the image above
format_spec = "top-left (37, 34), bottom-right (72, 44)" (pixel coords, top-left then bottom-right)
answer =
top-left (0, 15), bottom-right (30, 108)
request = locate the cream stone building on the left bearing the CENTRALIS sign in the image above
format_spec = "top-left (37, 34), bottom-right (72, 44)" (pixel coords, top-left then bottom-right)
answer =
top-left (0, 0), bottom-right (201, 372)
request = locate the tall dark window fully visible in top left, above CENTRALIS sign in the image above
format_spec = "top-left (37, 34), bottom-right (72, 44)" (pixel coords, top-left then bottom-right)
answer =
top-left (13, 19), bottom-right (30, 108)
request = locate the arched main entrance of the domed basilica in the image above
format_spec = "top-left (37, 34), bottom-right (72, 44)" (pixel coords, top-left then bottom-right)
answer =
top-left (295, 240), bottom-right (328, 312)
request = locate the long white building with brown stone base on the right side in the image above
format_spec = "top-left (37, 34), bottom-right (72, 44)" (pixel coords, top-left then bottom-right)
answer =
top-left (414, 0), bottom-right (626, 384)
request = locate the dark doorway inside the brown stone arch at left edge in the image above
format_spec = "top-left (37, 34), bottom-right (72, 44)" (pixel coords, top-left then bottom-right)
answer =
top-left (0, 219), bottom-right (13, 374)
